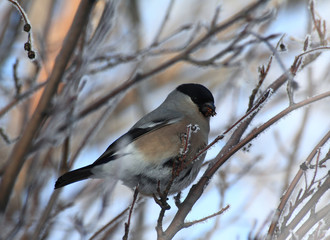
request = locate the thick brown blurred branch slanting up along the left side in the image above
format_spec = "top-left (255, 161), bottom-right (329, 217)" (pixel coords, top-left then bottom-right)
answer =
top-left (0, 0), bottom-right (95, 212)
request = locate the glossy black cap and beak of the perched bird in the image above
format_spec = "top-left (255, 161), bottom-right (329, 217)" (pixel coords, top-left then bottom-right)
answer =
top-left (176, 83), bottom-right (216, 117)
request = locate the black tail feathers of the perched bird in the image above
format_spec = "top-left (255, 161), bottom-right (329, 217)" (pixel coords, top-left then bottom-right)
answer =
top-left (55, 165), bottom-right (93, 189)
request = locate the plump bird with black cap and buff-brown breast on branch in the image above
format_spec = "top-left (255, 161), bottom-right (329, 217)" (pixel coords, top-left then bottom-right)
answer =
top-left (55, 83), bottom-right (216, 195)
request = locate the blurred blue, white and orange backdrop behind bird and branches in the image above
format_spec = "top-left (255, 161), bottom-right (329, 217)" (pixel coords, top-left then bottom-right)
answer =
top-left (0, 0), bottom-right (330, 239)
